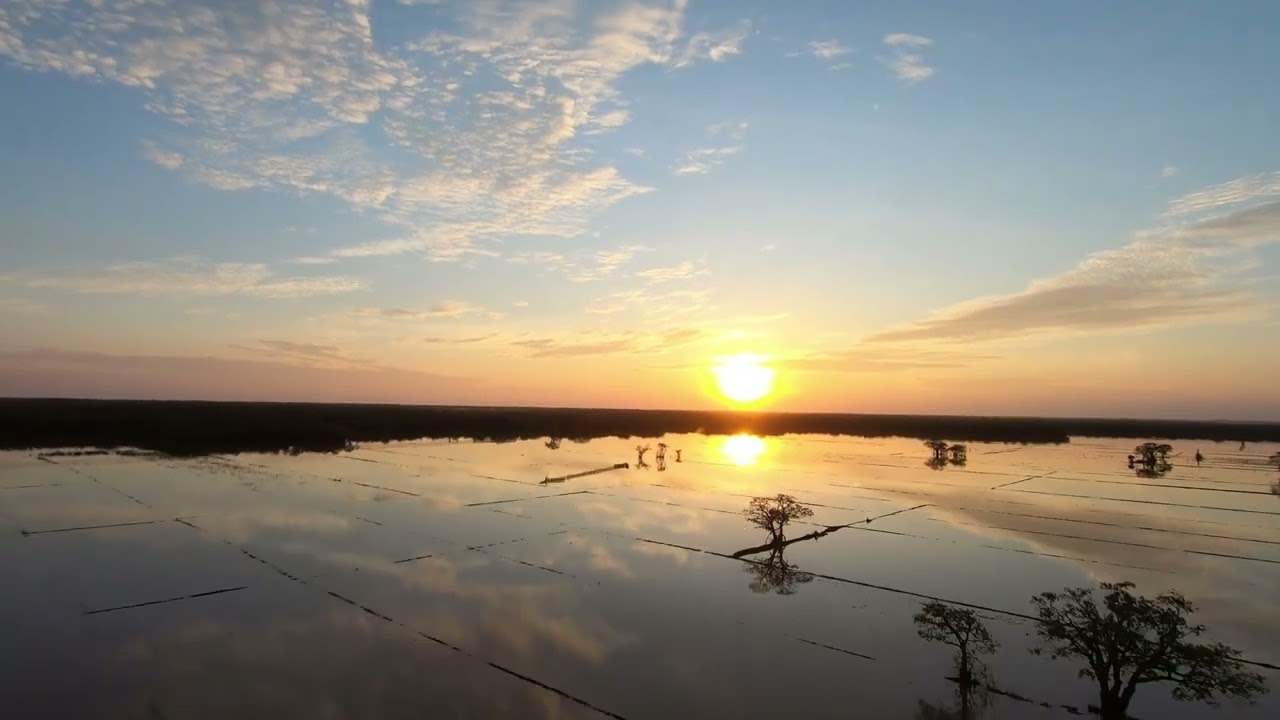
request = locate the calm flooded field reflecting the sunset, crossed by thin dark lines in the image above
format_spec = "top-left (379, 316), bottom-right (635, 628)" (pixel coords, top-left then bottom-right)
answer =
top-left (0, 436), bottom-right (1280, 720)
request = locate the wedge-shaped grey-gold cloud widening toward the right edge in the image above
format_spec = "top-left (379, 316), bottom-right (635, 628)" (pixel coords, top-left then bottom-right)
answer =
top-left (868, 181), bottom-right (1280, 342)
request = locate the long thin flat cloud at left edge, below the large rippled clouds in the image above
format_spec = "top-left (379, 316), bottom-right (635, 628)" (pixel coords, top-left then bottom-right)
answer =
top-left (0, 259), bottom-right (364, 299)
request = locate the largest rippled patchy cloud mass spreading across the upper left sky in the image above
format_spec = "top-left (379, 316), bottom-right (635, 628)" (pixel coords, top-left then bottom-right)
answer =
top-left (0, 0), bottom-right (750, 261)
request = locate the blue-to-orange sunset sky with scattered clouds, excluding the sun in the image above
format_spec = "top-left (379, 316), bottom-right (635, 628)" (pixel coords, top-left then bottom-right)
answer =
top-left (0, 0), bottom-right (1280, 420)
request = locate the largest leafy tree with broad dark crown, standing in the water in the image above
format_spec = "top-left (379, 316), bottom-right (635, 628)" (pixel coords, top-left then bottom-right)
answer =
top-left (1032, 583), bottom-right (1267, 720)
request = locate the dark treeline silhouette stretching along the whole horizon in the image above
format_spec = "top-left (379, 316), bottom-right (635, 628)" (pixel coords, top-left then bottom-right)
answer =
top-left (0, 398), bottom-right (1280, 455)
